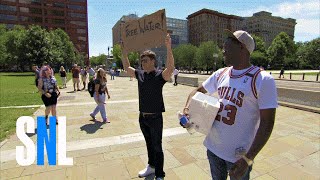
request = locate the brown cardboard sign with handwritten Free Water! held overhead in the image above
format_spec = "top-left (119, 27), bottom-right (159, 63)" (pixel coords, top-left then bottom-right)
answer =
top-left (121, 9), bottom-right (167, 52)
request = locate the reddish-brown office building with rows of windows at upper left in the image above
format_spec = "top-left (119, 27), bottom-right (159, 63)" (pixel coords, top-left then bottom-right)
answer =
top-left (0, 0), bottom-right (89, 64)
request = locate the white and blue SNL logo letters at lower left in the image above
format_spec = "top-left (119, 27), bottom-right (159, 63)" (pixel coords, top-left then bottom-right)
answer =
top-left (16, 116), bottom-right (73, 166)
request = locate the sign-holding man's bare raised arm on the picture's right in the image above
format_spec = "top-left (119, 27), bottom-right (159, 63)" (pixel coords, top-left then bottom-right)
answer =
top-left (162, 34), bottom-right (174, 81)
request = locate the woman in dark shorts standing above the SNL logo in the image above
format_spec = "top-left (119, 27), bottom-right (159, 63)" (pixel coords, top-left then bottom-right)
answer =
top-left (38, 66), bottom-right (60, 125)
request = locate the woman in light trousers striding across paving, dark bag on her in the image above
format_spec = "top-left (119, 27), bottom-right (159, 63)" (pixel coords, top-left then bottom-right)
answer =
top-left (90, 68), bottom-right (110, 123)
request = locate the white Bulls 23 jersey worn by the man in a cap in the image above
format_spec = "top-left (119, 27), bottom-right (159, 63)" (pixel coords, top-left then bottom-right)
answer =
top-left (202, 66), bottom-right (278, 163)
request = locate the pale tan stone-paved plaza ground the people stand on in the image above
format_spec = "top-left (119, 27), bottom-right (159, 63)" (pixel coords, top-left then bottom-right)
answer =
top-left (0, 77), bottom-right (320, 180)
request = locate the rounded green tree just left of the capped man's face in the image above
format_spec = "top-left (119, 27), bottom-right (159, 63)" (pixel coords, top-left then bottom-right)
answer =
top-left (195, 41), bottom-right (221, 73)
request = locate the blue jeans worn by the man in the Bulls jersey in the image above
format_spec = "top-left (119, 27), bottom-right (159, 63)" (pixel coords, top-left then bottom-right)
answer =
top-left (207, 149), bottom-right (252, 180)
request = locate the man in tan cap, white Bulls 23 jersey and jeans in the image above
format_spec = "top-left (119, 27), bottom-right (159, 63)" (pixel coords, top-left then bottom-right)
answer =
top-left (183, 30), bottom-right (278, 180)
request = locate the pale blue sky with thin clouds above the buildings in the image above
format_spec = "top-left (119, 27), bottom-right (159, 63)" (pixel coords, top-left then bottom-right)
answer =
top-left (88, 0), bottom-right (320, 57)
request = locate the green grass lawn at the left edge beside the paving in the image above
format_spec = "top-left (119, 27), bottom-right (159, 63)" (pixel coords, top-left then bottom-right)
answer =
top-left (0, 72), bottom-right (71, 141)
